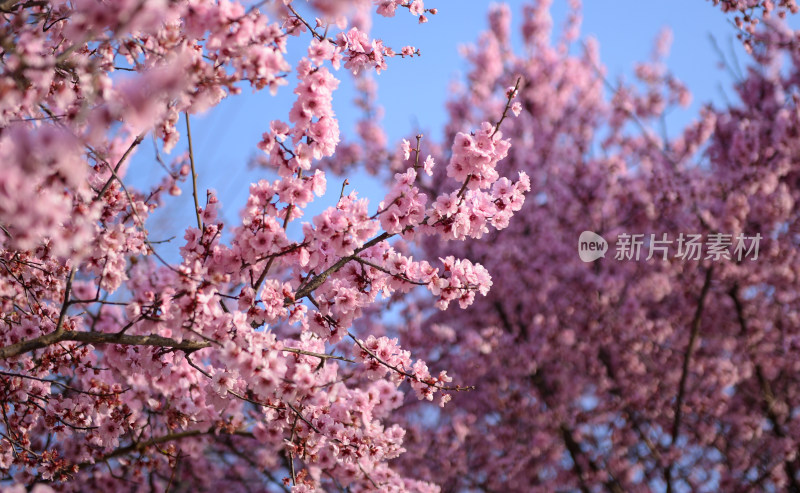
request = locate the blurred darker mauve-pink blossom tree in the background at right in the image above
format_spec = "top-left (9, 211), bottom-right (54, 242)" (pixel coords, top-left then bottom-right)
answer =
top-left (362, 0), bottom-right (800, 492)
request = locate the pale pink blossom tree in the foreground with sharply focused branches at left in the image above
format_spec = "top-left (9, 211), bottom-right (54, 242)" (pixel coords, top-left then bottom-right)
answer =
top-left (0, 0), bottom-right (529, 492)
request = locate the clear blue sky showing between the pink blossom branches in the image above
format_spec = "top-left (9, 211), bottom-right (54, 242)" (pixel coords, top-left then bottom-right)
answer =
top-left (136, 0), bottom-right (780, 259)
